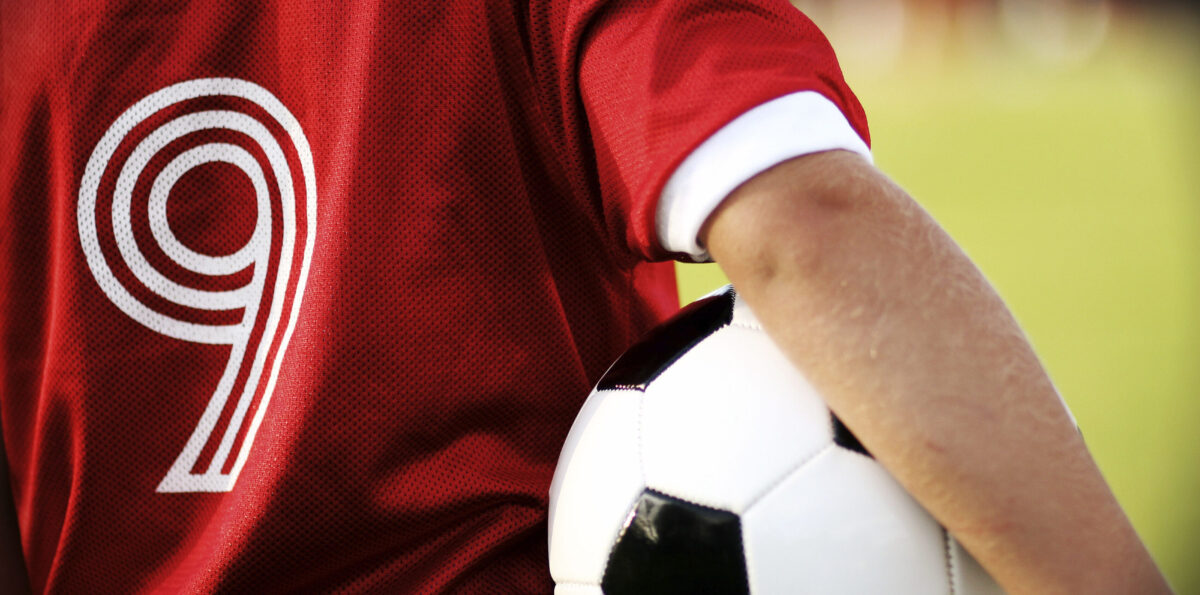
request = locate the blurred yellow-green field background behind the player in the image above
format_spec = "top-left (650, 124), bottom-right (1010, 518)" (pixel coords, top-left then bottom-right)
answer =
top-left (679, 0), bottom-right (1200, 594)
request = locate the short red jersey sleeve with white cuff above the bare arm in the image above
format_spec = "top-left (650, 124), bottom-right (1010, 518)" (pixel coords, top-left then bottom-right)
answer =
top-left (578, 0), bottom-right (870, 260)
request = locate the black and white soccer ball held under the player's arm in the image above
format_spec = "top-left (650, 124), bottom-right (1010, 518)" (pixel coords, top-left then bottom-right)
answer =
top-left (550, 288), bottom-right (1001, 595)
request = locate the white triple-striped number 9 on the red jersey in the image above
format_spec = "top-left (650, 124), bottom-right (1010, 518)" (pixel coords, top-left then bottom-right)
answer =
top-left (78, 78), bottom-right (317, 492)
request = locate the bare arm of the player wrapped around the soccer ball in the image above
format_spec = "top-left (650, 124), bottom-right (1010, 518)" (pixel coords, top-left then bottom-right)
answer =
top-left (701, 151), bottom-right (1169, 593)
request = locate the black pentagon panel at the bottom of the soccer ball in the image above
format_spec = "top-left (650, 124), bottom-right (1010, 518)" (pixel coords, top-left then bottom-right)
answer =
top-left (600, 489), bottom-right (750, 595)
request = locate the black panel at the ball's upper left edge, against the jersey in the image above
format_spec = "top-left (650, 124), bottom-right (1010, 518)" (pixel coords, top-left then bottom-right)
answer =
top-left (596, 289), bottom-right (734, 390)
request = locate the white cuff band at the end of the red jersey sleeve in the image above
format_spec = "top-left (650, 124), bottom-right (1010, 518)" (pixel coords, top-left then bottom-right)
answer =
top-left (655, 91), bottom-right (872, 262)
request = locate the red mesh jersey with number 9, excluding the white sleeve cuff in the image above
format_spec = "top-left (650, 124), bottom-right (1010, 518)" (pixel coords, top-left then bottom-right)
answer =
top-left (0, 0), bottom-right (868, 593)
